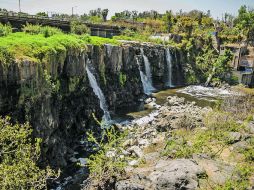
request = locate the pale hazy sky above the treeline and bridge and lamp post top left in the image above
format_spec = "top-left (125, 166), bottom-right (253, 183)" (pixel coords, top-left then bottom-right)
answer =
top-left (0, 0), bottom-right (254, 18)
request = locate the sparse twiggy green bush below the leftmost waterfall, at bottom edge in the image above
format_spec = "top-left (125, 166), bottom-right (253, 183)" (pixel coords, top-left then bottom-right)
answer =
top-left (87, 127), bottom-right (127, 189)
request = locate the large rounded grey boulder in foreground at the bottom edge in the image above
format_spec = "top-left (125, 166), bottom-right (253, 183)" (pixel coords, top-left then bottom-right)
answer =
top-left (149, 159), bottom-right (205, 190)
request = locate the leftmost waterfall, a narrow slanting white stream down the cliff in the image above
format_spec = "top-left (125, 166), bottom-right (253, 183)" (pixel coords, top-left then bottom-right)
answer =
top-left (86, 66), bottom-right (111, 122)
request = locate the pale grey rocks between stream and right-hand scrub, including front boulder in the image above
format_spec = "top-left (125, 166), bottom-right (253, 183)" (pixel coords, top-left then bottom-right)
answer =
top-left (115, 96), bottom-right (211, 190)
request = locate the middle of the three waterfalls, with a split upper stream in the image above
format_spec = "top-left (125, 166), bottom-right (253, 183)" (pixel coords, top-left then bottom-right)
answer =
top-left (137, 49), bottom-right (155, 95)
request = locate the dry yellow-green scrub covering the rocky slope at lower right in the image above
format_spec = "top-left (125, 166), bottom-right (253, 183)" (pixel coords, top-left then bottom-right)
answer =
top-left (162, 95), bottom-right (254, 190)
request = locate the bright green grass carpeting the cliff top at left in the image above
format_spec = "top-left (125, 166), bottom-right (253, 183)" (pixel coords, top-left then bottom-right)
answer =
top-left (0, 32), bottom-right (120, 63)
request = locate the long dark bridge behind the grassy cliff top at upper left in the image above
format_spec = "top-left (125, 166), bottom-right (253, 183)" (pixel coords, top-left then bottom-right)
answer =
top-left (0, 12), bottom-right (125, 38)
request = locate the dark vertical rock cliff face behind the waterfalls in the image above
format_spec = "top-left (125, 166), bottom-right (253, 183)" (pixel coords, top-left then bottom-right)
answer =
top-left (0, 44), bottom-right (187, 167)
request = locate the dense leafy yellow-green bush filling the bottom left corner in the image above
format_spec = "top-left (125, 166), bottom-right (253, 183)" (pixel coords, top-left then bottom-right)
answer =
top-left (0, 117), bottom-right (56, 190)
